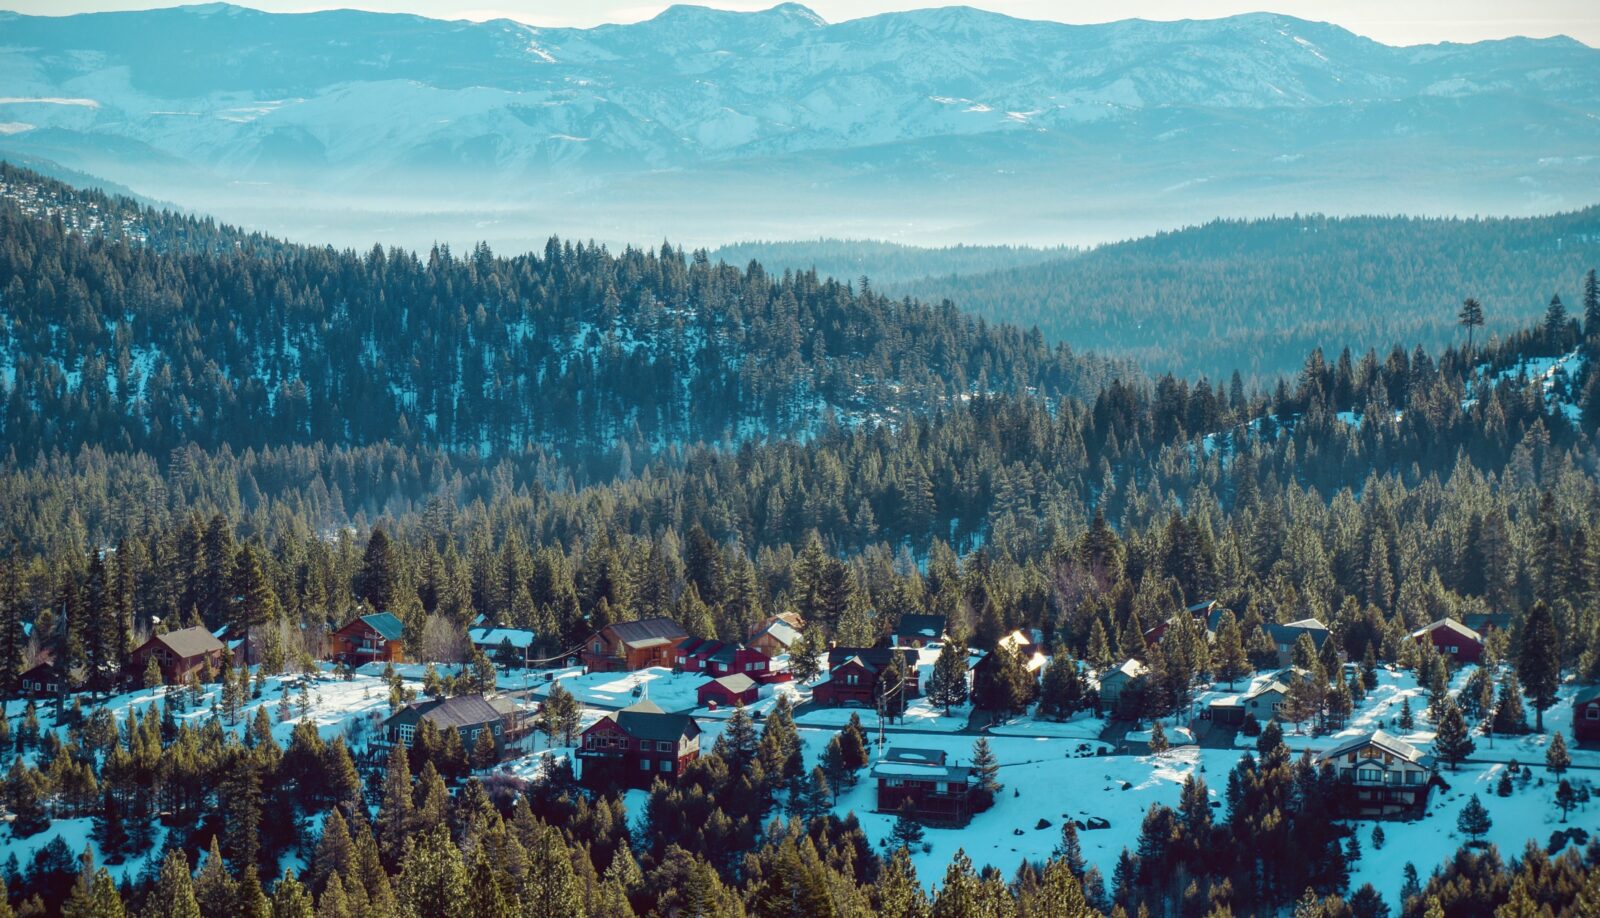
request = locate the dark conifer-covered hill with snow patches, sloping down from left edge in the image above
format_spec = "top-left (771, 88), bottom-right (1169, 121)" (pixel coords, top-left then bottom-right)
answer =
top-left (0, 170), bottom-right (1109, 473)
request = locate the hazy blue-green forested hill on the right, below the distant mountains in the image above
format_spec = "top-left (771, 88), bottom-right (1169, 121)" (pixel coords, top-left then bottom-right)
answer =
top-left (896, 208), bottom-right (1600, 381)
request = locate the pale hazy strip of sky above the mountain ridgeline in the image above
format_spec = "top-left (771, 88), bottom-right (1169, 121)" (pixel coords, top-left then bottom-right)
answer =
top-left (0, 0), bottom-right (1600, 46)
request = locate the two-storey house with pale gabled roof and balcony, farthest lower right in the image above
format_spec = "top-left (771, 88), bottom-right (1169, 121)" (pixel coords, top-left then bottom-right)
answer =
top-left (1317, 729), bottom-right (1435, 819)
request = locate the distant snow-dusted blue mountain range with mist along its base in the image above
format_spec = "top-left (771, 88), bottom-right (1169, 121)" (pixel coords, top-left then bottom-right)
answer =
top-left (0, 3), bottom-right (1600, 246)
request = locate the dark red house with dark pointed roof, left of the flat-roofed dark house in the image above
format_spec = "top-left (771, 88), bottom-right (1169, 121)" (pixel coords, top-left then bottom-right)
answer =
top-left (578, 699), bottom-right (701, 788)
